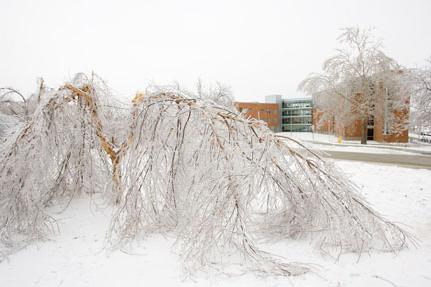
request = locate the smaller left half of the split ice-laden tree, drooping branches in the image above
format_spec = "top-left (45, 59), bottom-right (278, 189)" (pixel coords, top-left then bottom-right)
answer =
top-left (0, 75), bottom-right (118, 252)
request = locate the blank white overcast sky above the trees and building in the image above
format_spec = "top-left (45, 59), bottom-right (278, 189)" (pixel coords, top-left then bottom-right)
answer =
top-left (0, 0), bottom-right (431, 101)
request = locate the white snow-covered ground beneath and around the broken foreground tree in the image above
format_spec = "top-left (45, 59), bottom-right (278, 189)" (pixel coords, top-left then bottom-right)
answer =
top-left (0, 161), bottom-right (431, 287)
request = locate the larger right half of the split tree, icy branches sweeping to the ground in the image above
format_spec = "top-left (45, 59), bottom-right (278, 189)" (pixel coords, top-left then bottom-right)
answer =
top-left (111, 89), bottom-right (406, 274)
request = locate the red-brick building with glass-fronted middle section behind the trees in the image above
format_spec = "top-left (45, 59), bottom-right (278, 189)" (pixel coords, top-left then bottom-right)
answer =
top-left (235, 85), bottom-right (409, 143)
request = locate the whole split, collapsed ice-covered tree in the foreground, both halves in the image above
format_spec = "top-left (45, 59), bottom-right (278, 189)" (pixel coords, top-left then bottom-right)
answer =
top-left (0, 75), bottom-right (408, 276)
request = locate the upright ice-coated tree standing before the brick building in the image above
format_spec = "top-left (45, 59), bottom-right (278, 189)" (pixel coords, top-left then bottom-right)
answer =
top-left (299, 27), bottom-right (405, 144)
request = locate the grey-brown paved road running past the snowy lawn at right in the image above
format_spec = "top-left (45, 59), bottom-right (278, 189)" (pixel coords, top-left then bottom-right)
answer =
top-left (322, 150), bottom-right (431, 169)
